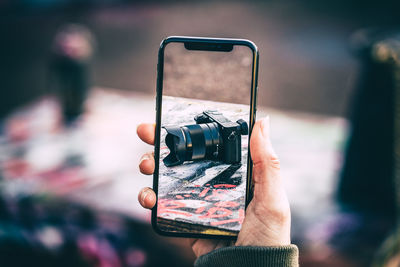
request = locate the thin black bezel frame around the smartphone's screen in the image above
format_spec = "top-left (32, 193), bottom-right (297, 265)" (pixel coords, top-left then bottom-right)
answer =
top-left (151, 36), bottom-right (259, 239)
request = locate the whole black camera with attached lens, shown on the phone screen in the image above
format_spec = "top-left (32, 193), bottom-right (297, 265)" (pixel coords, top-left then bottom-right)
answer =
top-left (163, 110), bottom-right (249, 167)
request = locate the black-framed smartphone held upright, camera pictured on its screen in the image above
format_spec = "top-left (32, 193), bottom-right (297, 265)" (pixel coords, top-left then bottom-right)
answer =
top-left (152, 36), bottom-right (258, 239)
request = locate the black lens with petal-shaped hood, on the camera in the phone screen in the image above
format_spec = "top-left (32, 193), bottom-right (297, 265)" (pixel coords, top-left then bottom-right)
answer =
top-left (163, 122), bottom-right (222, 167)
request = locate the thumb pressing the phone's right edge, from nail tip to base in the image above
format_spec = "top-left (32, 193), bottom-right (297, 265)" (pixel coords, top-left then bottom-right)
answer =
top-left (250, 117), bottom-right (282, 202)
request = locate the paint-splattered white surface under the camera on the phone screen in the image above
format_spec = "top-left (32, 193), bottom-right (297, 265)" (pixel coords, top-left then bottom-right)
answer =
top-left (158, 96), bottom-right (249, 234)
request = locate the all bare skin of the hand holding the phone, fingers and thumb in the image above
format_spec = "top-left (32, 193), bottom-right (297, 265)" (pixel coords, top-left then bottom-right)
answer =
top-left (137, 117), bottom-right (291, 257)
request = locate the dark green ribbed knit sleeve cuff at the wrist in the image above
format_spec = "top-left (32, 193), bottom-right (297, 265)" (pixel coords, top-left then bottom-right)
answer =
top-left (194, 245), bottom-right (299, 267)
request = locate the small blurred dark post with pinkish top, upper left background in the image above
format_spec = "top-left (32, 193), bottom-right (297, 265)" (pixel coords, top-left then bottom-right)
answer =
top-left (49, 24), bottom-right (94, 123)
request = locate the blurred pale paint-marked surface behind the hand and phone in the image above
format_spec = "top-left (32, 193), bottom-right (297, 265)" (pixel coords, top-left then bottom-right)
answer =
top-left (0, 88), bottom-right (354, 266)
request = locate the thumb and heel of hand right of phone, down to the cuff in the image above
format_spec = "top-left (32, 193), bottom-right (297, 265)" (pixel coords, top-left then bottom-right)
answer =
top-left (236, 117), bottom-right (290, 249)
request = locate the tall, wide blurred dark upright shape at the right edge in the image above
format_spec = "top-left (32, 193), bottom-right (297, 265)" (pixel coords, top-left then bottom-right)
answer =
top-left (338, 29), bottom-right (400, 220)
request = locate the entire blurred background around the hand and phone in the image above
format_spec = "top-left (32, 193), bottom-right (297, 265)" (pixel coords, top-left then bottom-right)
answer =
top-left (0, 0), bottom-right (400, 266)
